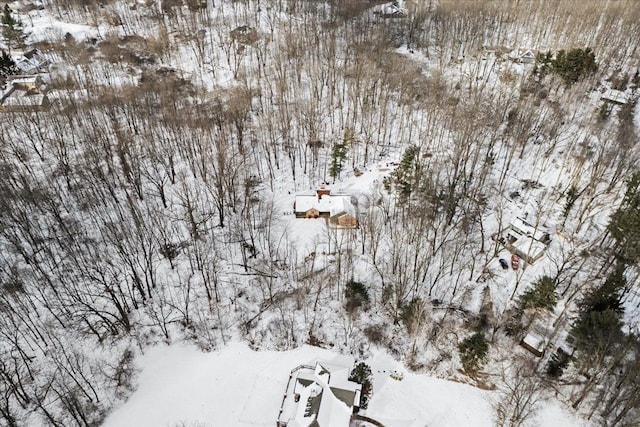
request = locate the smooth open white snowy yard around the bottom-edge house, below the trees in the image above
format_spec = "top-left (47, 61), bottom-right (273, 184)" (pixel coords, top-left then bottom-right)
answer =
top-left (104, 342), bottom-right (581, 427)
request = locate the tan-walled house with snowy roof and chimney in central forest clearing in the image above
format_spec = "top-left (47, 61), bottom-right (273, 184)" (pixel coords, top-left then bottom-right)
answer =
top-left (293, 184), bottom-right (358, 228)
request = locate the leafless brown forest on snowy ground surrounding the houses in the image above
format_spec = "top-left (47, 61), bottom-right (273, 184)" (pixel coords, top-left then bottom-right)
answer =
top-left (0, 0), bottom-right (640, 427)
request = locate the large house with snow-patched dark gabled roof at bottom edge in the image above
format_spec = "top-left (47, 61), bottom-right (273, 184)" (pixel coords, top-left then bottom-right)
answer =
top-left (276, 357), bottom-right (362, 427)
